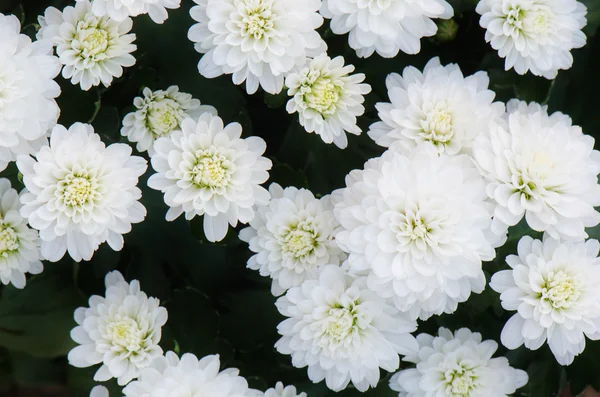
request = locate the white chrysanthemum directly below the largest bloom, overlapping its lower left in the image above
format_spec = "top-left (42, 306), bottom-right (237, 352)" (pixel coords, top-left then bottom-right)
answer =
top-left (275, 265), bottom-right (417, 392)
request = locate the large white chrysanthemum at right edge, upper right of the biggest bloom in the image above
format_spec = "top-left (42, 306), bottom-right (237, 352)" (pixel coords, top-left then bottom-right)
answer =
top-left (473, 100), bottom-right (600, 240)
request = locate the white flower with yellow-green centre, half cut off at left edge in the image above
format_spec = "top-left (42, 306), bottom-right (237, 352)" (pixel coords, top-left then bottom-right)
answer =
top-left (0, 178), bottom-right (44, 288)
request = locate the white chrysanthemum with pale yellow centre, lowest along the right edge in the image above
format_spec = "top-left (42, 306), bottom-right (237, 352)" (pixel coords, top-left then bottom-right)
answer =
top-left (490, 235), bottom-right (600, 365)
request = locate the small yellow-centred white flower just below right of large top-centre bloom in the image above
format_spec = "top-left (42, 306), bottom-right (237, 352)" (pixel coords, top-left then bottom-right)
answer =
top-left (285, 54), bottom-right (371, 149)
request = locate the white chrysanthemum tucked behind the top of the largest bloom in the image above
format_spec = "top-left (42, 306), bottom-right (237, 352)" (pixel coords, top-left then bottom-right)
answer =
top-left (368, 57), bottom-right (504, 154)
